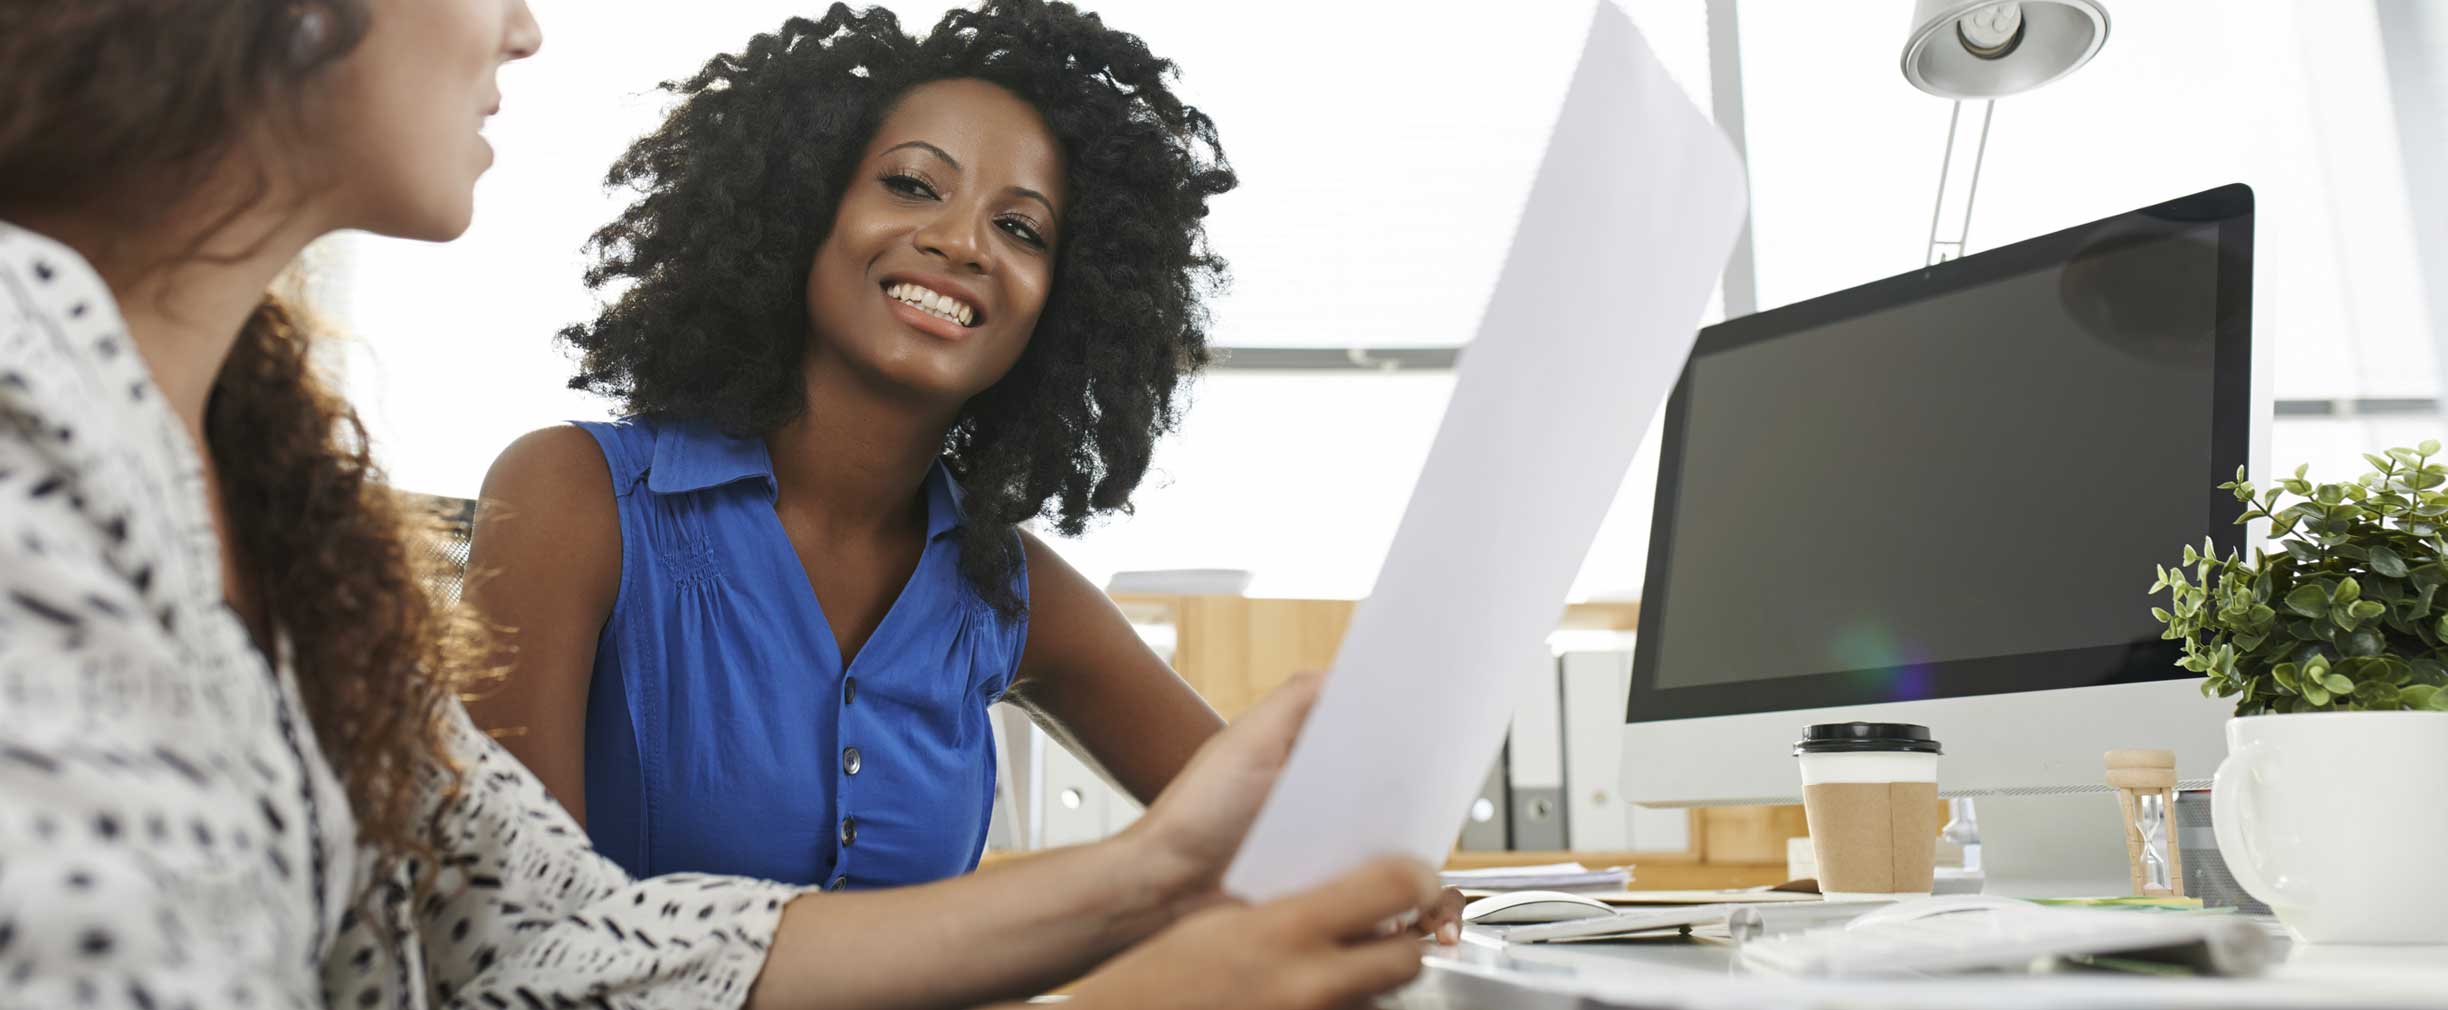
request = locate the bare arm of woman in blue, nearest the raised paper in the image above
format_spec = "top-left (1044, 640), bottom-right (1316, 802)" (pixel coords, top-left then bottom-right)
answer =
top-left (1011, 533), bottom-right (1224, 805)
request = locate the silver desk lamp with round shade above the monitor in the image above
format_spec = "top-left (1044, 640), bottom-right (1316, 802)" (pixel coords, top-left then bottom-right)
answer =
top-left (1905, 0), bottom-right (2108, 264)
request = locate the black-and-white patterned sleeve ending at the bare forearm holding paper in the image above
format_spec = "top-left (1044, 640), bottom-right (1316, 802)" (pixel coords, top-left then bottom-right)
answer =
top-left (326, 707), bottom-right (798, 1010)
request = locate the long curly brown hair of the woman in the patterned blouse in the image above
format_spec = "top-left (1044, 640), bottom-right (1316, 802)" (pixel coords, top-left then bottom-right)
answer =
top-left (0, 0), bottom-right (482, 871)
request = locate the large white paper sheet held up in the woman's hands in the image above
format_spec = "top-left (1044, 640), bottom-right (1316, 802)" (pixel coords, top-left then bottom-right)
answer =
top-left (1224, 2), bottom-right (1743, 900)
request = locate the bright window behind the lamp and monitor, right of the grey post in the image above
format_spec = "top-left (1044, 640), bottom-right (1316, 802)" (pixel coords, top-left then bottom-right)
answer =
top-left (1743, 0), bottom-right (2441, 489)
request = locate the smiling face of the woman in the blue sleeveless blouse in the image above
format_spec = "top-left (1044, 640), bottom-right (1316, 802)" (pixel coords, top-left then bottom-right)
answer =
top-left (808, 81), bottom-right (1065, 406)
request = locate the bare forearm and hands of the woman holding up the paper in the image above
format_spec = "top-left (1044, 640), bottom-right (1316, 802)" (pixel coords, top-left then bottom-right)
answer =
top-left (749, 675), bottom-right (1435, 1010)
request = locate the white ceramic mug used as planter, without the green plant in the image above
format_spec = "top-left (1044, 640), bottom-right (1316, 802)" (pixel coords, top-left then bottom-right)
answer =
top-left (2211, 712), bottom-right (2448, 944)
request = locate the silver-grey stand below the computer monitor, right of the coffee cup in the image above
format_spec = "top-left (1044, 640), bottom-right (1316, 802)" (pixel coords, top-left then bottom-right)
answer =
top-left (1973, 790), bottom-right (2132, 898)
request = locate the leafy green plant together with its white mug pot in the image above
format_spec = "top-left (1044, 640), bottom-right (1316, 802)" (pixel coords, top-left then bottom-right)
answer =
top-left (2152, 443), bottom-right (2448, 944)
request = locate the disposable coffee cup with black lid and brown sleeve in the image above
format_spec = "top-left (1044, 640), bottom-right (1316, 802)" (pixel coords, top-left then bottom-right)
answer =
top-left (1794, 721), bottom-right (1941, 900)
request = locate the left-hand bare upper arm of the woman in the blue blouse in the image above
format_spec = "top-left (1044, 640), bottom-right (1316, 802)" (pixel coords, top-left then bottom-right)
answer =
top-left (468, 426), bottom-right (622, 827)
